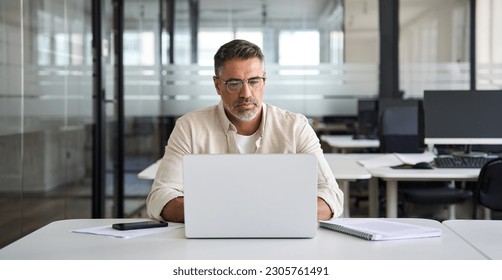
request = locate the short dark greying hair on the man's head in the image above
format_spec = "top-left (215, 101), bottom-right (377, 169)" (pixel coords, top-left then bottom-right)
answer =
top-left (214, 40), bottom-right (265, 77)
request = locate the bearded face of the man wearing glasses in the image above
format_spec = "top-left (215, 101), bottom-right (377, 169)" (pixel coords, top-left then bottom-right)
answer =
top-left (213, 57), bottom-right (265, 122)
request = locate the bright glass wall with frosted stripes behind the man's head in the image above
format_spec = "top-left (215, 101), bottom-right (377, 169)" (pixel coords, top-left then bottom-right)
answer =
top-left (161, 0), bottom-right (378, 120)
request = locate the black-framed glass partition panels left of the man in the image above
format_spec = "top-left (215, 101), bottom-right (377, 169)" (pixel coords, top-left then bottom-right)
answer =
top-left (0, 0), bottom-right (160, 247)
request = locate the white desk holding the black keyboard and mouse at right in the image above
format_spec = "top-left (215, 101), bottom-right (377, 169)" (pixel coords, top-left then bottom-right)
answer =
top-left (368, 167), bottom-right (479, 218)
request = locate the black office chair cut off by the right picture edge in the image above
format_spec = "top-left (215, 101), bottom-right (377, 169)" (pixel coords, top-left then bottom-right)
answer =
top-left (472, 158), bottom-right (502, 219)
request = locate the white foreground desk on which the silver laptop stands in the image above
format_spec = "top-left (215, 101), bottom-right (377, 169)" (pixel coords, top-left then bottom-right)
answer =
top-left (0, 219), bottom-right (486, 260)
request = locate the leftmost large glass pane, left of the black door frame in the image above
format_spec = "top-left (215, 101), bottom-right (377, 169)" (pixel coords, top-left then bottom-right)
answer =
top-left (0, 0), bottom-right (92, 247)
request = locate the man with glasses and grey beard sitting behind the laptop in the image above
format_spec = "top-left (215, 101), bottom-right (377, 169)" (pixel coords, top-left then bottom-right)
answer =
top-left (147, 40), bottom-right (343, 222)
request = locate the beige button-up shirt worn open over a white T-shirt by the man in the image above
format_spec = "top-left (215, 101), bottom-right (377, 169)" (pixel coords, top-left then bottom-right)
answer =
top-left (146, 102), bottom-right (343, 220)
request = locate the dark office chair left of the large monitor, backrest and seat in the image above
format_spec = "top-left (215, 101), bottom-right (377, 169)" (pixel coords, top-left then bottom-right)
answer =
top-left (380, 102), bottom-right (472, 218)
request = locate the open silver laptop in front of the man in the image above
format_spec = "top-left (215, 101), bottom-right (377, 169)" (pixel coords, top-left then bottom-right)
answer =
top-left (183, 154), bottom-right (317, 238)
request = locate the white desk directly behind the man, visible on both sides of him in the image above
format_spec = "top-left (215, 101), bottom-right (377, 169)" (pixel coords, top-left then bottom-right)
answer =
top-left (138, 154), bottom-right (378, 217)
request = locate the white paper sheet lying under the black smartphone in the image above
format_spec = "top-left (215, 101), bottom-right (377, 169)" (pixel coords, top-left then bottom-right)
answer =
top-left (71, 223), bottom-right (184, 238)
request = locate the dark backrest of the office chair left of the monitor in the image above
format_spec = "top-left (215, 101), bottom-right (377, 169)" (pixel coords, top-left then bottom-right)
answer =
top-left (379, 106), bottom-right (423, 153)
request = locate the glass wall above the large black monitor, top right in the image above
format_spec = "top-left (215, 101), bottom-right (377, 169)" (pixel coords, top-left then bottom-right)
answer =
top-left (399, 0), bottom-right (502, 95)
